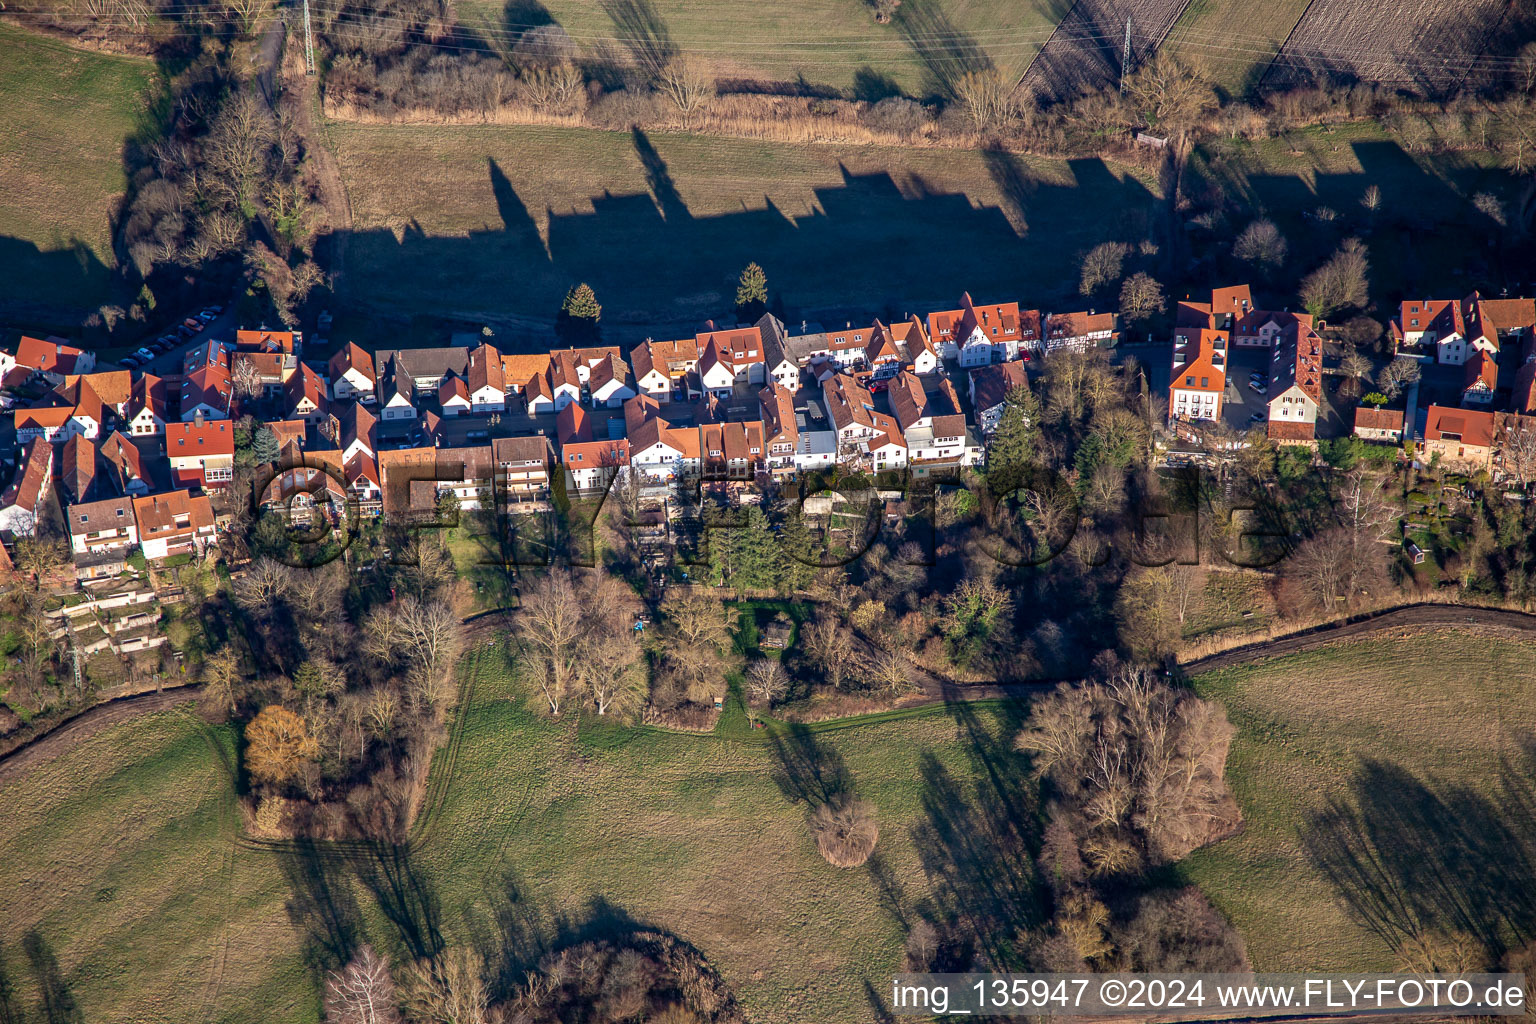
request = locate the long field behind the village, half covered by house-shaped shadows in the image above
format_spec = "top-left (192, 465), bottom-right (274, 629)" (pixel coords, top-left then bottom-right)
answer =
top-left (330, 124), bottom-right (1155, 330)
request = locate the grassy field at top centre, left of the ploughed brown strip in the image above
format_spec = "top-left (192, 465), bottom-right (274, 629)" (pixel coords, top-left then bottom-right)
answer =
top-left (458, 0), bottom-right (1071, 95)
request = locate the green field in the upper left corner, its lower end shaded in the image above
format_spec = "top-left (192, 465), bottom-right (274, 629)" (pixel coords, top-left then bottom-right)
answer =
top-left (0, 25), bottom-right (158, 316)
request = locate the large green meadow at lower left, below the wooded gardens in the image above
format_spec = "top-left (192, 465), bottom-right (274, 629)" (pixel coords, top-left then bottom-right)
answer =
top-left (0, 649), bottom-right (1031, 1024)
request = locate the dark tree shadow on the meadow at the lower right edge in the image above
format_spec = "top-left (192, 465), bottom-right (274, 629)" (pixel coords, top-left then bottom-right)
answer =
top-left (1303, 748), bottom-right (1536, 960)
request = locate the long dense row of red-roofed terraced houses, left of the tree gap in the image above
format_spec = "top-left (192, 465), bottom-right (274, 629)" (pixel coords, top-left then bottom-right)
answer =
top-left (0, 295), bottom-right (1117, 576)
